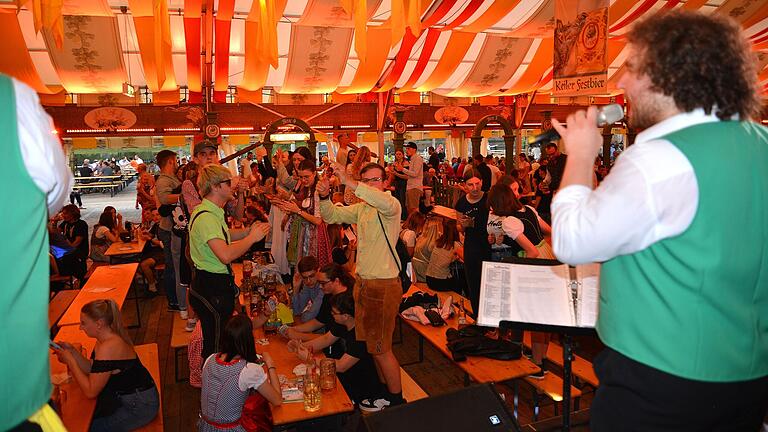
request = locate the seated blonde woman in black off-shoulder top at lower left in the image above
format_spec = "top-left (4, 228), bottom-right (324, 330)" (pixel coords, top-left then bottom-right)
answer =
top-left (56, 300), bottom-right (160, 432)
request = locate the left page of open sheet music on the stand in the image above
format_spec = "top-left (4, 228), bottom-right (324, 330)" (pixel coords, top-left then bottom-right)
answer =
top-left (478, 262), bottom-right (575, 327)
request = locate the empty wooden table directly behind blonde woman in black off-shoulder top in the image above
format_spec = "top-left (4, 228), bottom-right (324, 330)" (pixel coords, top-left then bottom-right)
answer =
top-left (59, 263), bottom-right (141, 327)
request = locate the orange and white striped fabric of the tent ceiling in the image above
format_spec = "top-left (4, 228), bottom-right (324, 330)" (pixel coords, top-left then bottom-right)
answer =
top-left (0, 0), bottom-right (768, 100)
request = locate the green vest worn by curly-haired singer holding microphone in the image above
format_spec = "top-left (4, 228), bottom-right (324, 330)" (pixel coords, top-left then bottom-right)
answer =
top-left (597, 121), bottom-right (768, 382)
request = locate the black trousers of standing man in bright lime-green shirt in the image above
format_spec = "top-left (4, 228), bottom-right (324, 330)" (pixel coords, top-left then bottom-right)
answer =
top-left (189, 270), bottom-right (235, 360)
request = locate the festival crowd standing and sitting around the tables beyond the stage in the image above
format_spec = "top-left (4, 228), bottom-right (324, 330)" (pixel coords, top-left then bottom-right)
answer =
top-left (40, 87), bottom-right (632, 430)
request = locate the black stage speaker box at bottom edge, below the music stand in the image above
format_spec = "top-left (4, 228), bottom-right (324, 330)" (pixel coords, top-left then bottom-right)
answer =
top-left (358, 384), bottom-right (520, 432)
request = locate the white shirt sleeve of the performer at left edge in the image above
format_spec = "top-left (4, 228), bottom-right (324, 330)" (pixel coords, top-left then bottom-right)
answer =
top-left (13, 79), bottom-right (74, 214)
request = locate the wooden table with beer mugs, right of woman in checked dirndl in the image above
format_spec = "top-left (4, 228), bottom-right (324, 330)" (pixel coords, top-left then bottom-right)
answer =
top-left (253, 329), bottom-right (354, 430)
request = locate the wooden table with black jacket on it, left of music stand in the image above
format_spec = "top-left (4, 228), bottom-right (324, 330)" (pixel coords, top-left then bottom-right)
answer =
top-left (400, 285), bottom-right (539, 384)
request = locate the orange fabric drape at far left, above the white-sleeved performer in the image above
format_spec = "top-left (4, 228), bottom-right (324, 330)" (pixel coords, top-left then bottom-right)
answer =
top-left (0, 9), bottom-right (53, 94)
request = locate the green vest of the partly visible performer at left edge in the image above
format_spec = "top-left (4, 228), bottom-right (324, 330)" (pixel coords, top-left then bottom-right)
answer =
top-left (0, 75), bottom-right (51, 430)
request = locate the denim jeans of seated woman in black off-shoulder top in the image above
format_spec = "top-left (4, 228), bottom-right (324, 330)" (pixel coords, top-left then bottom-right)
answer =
top-left (90, 387), bottom-right (163, 432)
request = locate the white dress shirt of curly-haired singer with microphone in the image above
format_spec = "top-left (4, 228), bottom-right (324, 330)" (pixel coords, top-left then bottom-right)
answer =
top-left (552, 109), bottom-right (719, 265)
